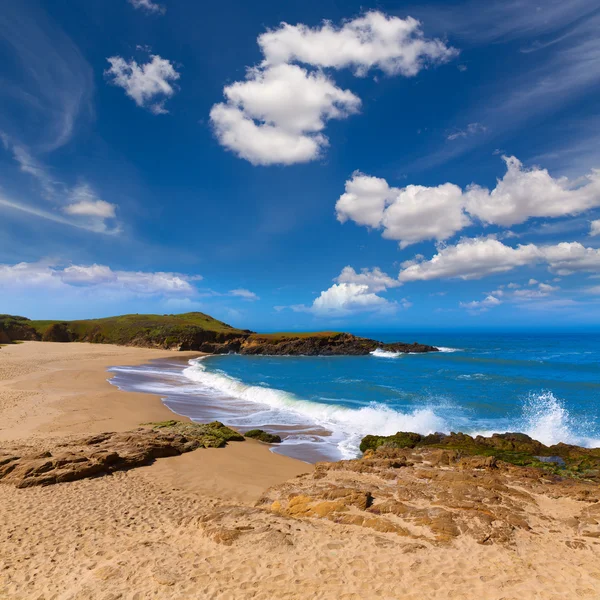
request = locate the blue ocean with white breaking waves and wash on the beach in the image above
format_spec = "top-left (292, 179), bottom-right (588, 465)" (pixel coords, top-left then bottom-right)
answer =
top-left (110, 333), bottom-right (600, 462)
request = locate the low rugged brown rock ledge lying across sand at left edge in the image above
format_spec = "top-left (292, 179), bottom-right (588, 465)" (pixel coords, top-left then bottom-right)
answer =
top-left (0, 421), bottom-right (244, 488)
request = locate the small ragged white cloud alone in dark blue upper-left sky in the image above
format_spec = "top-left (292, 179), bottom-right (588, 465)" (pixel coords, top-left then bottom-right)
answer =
top-left (104, 54), bottom-right (180, 115)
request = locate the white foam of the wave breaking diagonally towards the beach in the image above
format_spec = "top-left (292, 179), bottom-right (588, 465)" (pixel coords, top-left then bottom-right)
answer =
top-left (183, 360), bottom-right (448, 457)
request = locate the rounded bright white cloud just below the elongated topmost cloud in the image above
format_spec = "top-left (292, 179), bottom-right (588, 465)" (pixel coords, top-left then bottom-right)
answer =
top-left (210, 65), bottom-right (360, 165)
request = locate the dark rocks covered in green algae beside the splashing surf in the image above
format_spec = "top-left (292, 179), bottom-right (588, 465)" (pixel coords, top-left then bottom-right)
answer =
top-left (360, 431), bottom-right (600, 482)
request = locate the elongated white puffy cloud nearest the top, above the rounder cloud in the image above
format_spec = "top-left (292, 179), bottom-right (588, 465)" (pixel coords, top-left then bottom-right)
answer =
top-left (258, 11), bottom-right (457, 77)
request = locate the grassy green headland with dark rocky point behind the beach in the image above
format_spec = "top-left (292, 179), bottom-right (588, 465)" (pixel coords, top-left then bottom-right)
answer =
top-left (0, 312), bottom-right (438, 356)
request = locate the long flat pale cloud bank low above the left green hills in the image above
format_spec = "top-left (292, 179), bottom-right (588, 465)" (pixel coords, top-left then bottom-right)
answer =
top-left (0, 261), bottom-right (198, 296)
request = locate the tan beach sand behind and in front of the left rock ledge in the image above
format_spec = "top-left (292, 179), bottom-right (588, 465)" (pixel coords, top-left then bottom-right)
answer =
top-left (0, 342), bottom-right (600, 600)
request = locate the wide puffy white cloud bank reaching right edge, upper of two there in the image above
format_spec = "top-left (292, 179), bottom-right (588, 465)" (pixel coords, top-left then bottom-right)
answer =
top-left (336, 156), bottom-right (600, 247)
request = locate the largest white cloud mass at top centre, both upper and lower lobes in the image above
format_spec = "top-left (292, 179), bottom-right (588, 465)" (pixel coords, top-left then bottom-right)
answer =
top-left (210, 11), bottom-right (456, 165)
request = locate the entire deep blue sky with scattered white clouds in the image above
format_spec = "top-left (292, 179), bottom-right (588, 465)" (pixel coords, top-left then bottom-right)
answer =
top-left (0, 0), bottom-right (600, 331)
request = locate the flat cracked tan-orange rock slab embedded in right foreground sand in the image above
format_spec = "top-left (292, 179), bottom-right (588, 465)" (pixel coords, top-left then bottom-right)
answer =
top-left (259, 446), bottom-right (600, 546)
